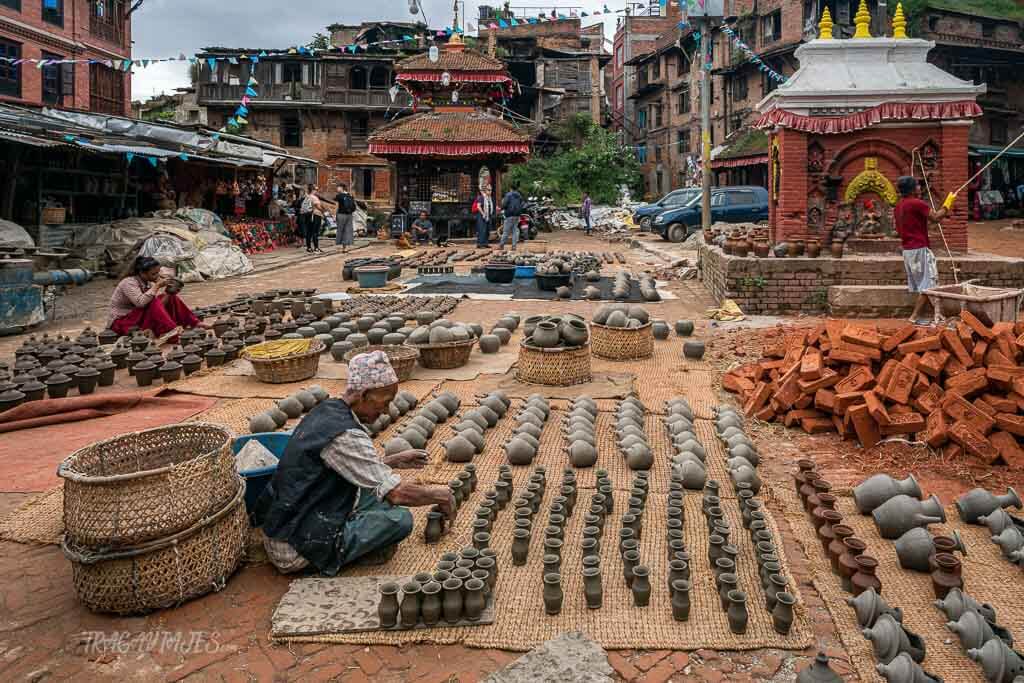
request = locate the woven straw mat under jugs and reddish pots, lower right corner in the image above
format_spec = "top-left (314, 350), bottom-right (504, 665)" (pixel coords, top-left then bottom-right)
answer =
top-left (774, 479), bottom-right (1024, 683)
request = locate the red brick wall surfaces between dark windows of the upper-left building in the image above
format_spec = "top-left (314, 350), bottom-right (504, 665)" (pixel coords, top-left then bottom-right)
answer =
top-left (0, 0), bottom-right (131, 116)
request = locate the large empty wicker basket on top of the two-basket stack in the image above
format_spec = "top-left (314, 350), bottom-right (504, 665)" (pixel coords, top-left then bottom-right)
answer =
top-left (57, 422), bottom-right (238, 549)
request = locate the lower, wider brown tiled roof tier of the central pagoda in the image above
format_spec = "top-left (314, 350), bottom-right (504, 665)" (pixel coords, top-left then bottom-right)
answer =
top-left (370, 112), bottom-right (530, 157)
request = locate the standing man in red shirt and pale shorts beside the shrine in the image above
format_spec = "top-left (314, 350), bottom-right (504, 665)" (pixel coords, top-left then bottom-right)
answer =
top-left (893, 175), bottom-right (956, 324)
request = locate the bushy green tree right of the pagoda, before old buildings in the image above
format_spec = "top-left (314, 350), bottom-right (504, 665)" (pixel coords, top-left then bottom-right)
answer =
top-left (509, 114), bottom-right (642, 204)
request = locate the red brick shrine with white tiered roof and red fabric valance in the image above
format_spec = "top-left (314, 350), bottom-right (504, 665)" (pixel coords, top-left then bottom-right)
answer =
top-left (757, 15), bottom-right (985, 253)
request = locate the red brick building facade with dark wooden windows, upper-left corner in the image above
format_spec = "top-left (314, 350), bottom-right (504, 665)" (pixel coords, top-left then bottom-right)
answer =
top-left (0, 0), bottom-right (131, 116)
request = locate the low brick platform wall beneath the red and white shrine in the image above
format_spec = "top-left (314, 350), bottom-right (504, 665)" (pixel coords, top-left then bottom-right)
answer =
top-left (697, 243), bottom-right (1024, 315)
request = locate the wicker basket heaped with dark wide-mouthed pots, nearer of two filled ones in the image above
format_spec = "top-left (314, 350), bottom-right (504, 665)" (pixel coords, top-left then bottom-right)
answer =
top-left (516, 313), bottom-right (592, 386)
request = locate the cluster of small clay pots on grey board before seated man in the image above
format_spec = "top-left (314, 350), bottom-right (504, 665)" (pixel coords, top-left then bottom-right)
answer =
top-left (377, 540), bottom-right (498, 630)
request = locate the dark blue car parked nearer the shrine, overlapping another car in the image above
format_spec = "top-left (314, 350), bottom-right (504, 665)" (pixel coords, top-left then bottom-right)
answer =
top-left (652, 185), bottom-right (768, 242)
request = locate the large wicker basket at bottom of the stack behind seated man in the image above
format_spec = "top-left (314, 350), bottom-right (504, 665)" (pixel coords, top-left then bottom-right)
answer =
top-left (60, 475), bottom-right (249, 614)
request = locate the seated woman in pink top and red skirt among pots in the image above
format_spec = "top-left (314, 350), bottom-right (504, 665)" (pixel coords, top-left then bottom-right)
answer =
top-left (108, 256), bottom-right (206, 337)
